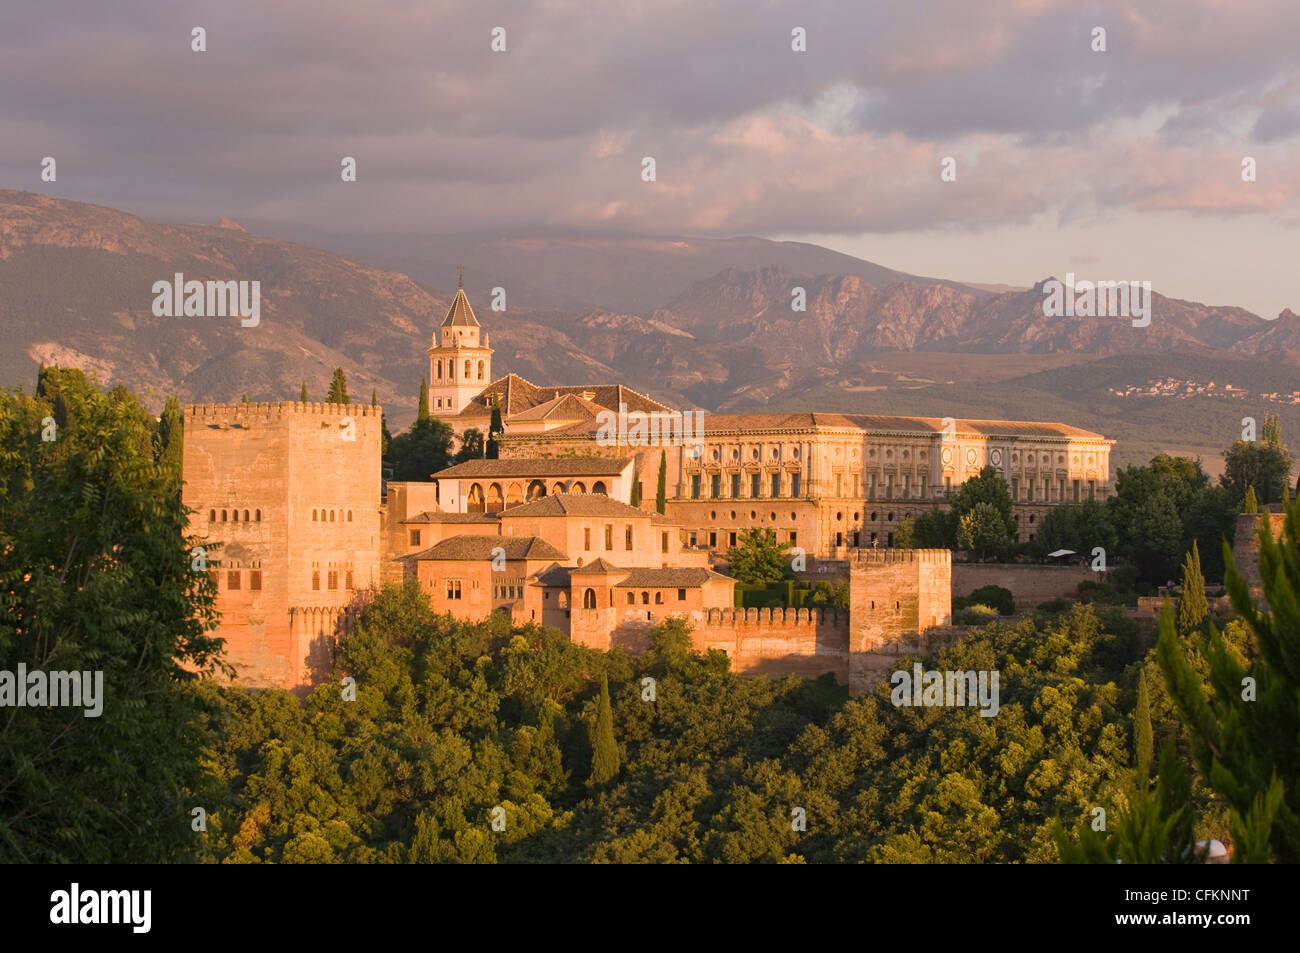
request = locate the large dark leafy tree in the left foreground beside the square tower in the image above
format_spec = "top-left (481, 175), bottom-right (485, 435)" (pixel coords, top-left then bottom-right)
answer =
top-left (0, 368), bottom-right (220, 863)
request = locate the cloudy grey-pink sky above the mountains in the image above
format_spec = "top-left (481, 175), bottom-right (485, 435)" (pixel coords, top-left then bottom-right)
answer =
top-left (0, 0), bottom-right (1300, 317)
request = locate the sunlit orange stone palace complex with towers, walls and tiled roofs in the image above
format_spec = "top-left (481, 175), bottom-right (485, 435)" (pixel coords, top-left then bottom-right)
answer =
top-left (183, 278), bottom-right (1114, 692)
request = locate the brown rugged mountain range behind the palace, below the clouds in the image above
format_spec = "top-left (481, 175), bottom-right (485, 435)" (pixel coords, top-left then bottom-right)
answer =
top-left (0, 191), bottom-right (1300, 460)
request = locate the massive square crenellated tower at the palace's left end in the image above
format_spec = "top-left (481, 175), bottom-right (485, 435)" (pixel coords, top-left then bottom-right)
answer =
top-left (182, 402), bottom-right (382, 688)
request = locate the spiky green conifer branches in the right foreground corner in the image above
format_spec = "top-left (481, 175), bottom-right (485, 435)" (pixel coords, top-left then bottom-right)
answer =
top-left (1157, 504), bottom-right (1300, 863)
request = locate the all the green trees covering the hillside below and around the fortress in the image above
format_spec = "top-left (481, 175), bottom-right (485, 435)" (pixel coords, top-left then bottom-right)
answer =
top-left (0, 371), bottom-right (1300, 863)
